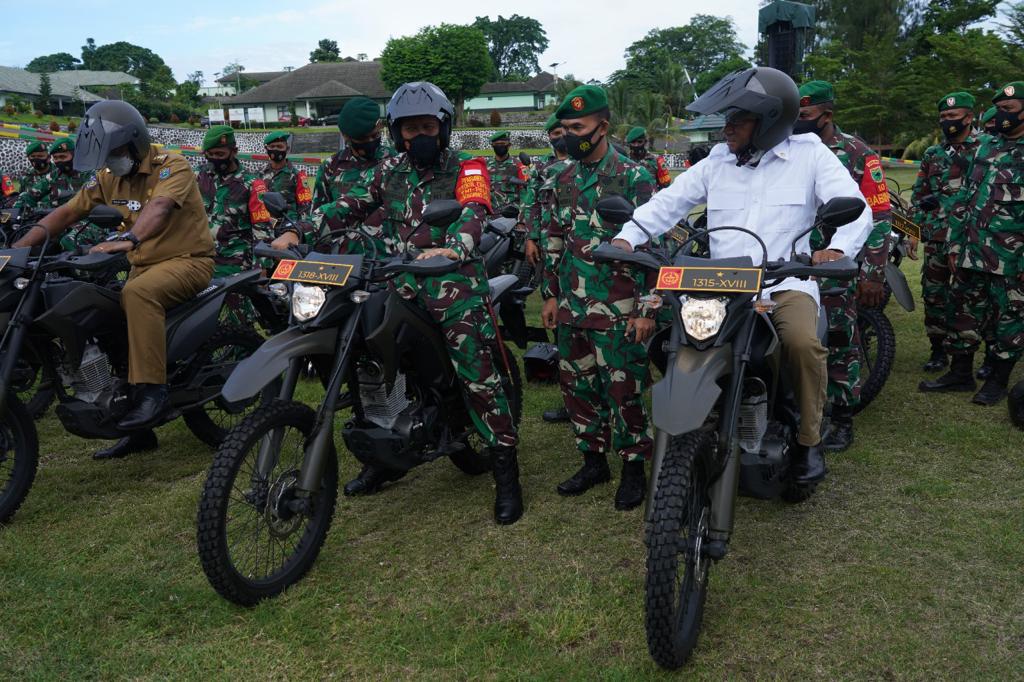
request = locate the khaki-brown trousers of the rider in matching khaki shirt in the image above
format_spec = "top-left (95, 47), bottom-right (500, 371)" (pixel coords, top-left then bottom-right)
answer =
top-left (121, 256), bottom-right (213, 384)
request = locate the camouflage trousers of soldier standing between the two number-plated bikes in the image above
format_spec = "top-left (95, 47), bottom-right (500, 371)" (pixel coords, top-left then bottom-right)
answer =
top-left (558, 325), bottom-right (651, 462)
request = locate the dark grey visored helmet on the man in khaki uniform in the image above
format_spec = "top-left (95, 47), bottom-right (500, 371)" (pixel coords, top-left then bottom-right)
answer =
top-left (75, 99), bottom-right (150, 171)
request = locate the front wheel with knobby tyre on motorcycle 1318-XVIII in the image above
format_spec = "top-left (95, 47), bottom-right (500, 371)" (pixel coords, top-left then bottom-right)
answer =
top-left (196, 400), bottom-right (338, 606)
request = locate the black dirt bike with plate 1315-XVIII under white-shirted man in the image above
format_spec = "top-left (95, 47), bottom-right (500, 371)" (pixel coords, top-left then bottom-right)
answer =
top-left (593, 197), bottom-right (864, 669)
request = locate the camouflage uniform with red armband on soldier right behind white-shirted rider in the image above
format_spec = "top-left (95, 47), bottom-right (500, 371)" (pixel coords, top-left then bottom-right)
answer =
top-left (811, 126), bottom-right (892, 408)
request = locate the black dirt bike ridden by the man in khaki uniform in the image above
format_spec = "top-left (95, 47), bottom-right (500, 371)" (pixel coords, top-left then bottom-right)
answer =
top-left (0, 206), bottom-right (276, 521)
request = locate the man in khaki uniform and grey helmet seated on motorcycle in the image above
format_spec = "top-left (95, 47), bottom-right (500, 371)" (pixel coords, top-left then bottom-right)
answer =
top-left (15, 100), bottom-right (214, 457)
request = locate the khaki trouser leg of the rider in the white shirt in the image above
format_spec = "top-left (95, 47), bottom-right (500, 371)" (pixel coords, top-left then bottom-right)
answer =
top-left (771, 291), bottom-right (828, 445)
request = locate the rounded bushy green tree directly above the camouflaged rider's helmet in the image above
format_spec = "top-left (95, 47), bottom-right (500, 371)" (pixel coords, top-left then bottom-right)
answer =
top-left (381, 24), bottom-right (494, 123)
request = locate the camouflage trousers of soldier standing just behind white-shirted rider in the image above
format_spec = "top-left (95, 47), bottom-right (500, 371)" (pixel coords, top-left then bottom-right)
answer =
top-left (821, 280), bottom-right (862, 408)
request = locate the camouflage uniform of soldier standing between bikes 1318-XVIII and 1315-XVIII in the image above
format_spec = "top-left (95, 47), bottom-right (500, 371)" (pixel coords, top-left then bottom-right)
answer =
top-left (541, 145), bottom-right (654, 461)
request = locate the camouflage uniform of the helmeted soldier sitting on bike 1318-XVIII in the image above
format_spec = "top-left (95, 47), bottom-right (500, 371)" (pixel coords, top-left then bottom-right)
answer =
top-left (313, 151), bottom-right (516, 446)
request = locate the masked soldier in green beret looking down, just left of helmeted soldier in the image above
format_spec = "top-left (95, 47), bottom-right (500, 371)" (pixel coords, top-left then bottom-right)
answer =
top-left (313, 97), bottom-right (396, 208)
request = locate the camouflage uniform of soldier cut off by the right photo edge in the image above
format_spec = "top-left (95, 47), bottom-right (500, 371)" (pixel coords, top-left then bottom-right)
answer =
top-left (946, 135), bottom-right (1024, 361)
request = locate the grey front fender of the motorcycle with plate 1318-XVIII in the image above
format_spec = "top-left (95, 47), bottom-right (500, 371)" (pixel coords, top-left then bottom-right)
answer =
top-left (220, 327), bottom-right (338, 402)
